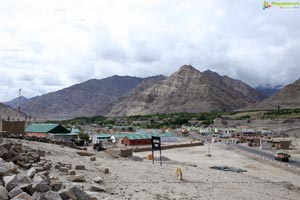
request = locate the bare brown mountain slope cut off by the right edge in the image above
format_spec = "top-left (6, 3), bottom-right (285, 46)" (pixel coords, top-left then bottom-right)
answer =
top-left (245, 80), bottom-right (300, 110)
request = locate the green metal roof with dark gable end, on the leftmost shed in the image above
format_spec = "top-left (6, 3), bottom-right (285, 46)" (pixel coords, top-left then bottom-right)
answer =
top-left (25, 124), bottom-right (70, 133)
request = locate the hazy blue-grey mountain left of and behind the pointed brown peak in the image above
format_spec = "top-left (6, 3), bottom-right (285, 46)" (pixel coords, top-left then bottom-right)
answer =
top-left (20, 75), bottom-right (144, 119)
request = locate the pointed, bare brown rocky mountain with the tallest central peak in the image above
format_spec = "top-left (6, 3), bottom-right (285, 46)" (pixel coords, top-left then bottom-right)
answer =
top-left (107, 65), bottom-right (265, 116)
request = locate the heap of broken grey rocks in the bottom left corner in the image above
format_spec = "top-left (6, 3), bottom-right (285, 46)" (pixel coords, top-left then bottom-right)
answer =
top-left (0, 141), bottom-right (91, 200)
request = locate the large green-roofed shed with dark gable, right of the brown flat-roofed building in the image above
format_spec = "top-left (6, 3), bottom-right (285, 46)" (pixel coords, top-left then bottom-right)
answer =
top-left (25, 124), bottom-right (71, 137)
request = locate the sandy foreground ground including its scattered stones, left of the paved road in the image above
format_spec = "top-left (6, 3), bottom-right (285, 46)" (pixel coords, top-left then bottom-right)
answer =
top-left (0, 141), bottom-right (300, 200)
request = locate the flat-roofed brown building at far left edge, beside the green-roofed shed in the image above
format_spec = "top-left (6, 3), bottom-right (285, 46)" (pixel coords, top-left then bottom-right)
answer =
top-left (0, 119), bottom-right (25, 134)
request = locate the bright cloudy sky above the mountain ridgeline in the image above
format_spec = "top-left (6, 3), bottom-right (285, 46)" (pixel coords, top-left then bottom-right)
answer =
top-left (0, 0), bottom-right (300, 101)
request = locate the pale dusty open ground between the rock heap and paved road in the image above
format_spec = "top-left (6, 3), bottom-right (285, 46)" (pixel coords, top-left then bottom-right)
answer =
top-left (24, 141), bottom-right (300, 200)
